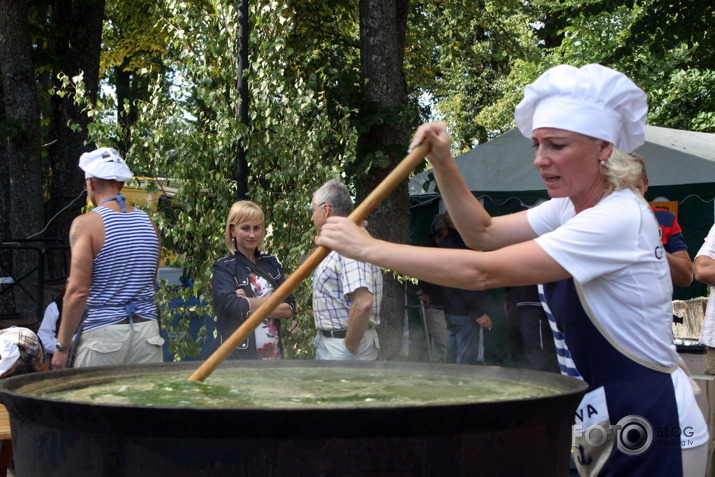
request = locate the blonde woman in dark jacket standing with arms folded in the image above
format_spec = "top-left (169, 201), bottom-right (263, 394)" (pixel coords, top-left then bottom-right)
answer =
top-left (212, 200), bottom-right (295, 359)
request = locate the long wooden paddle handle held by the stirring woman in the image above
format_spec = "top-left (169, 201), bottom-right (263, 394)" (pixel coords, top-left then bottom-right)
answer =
top-left (189, 141), bottom-right (430, 381)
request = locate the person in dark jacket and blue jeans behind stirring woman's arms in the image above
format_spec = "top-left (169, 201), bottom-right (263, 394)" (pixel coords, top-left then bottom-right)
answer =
top-left (438, 212), bottom-right (492, 364)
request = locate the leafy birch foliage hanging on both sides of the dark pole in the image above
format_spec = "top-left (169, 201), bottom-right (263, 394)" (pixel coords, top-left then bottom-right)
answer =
top-left (84, 0), bottom-right (355, 360)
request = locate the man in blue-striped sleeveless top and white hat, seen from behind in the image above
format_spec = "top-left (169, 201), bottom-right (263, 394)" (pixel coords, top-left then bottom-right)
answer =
top-left (52, 147), bottom-right (164, 369)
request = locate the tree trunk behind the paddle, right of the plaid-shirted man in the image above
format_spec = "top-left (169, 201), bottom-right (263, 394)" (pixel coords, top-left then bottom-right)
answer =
top-left (357, 0), bottom-right (410, 360)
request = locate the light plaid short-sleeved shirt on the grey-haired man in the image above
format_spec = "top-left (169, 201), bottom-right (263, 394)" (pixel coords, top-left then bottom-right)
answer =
top-left (313, 252), bottom-right (382, 330)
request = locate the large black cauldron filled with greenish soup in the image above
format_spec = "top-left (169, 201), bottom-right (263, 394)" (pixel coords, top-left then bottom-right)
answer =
top-left (0, 360), bottom-right (586, 477)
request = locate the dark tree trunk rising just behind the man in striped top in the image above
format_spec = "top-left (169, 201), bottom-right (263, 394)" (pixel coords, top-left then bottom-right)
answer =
top-left (46, 0), bottom-right (105, 253)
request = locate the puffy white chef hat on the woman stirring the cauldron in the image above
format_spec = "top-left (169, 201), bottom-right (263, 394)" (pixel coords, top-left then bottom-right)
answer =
top-left (514, 64), bottom-right (648, 152)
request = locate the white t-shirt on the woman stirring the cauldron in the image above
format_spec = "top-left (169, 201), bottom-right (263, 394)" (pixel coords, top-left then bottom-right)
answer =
top-left (528, 189), bottom-right (678, 368)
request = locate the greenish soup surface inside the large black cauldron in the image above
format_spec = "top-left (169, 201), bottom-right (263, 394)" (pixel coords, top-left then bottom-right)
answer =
top-left (40, 367), bottom-right (559, 408)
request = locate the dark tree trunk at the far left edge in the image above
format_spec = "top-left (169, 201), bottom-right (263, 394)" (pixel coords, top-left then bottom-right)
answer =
top-left (0, 0), bottom-right (44, 319)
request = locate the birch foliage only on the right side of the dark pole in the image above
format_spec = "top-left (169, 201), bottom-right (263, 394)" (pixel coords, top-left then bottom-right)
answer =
top-left (243, 2), bottom-right (355, 358)
